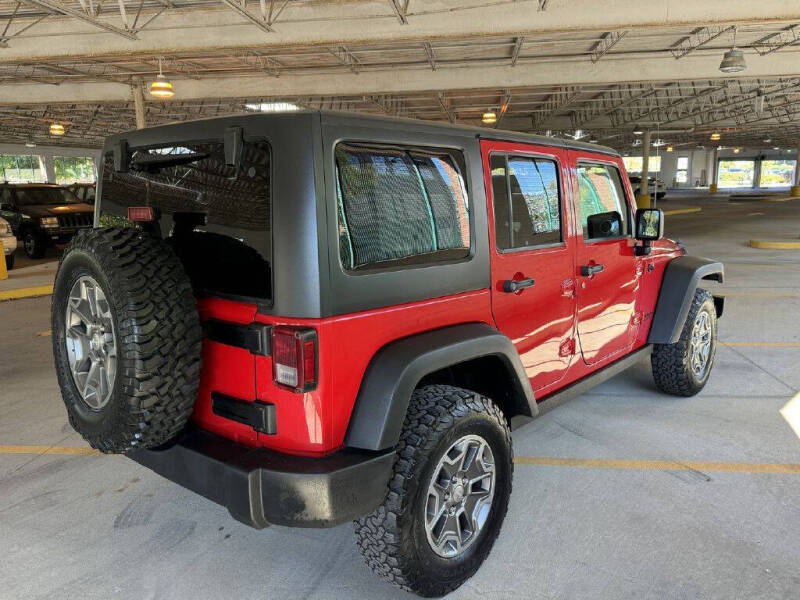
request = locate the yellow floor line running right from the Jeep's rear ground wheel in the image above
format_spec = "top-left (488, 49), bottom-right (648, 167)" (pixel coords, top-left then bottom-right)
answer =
top-left (514, 456), bottom-right (800, 474)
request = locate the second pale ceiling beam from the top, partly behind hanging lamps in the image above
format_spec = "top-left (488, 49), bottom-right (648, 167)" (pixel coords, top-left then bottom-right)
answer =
top-left (0, 47), bottom-right (800, 105)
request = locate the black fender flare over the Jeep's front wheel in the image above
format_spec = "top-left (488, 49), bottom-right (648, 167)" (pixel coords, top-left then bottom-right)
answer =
top-left (647, 256), bottom-right (725, 344)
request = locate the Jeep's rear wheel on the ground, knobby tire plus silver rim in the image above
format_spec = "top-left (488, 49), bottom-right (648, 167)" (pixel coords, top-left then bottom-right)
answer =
top-left (355, 385), bottom-right (513, 597)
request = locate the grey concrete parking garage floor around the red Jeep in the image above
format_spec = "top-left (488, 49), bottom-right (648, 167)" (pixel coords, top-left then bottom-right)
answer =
top-left (0, 194), bottom-right (800, 600)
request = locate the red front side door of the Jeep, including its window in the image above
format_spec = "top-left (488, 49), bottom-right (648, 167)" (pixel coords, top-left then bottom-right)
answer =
top-left (570, 151), bottom-right (639, 364)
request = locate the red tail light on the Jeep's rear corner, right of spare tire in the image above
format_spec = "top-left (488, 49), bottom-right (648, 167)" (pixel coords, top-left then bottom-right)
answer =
top-left (272, 327), bottom-right (317, 392)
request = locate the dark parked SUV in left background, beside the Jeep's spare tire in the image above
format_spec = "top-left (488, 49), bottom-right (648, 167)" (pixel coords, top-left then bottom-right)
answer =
top-left (0, 183), bottom-right (94, 258)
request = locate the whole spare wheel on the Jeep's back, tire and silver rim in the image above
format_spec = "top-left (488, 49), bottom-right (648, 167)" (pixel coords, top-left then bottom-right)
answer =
top-left (51, 228), bottom-right (202, 453)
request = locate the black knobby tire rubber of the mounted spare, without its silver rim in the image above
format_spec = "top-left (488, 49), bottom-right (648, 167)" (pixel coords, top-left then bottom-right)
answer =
top-left (51, 228), bottom-right (202, 453)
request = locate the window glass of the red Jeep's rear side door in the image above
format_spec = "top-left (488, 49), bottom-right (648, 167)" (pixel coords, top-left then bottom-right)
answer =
top-left (489, 154), bottom-right (562, 251)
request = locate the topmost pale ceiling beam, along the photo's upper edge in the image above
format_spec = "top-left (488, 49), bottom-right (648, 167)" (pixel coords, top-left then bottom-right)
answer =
top-left (0, 0), bottom-right (800, 62)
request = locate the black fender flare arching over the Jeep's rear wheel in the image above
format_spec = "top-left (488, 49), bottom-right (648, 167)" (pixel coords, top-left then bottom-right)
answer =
top-left (344, 323), bottom-right (539, 450)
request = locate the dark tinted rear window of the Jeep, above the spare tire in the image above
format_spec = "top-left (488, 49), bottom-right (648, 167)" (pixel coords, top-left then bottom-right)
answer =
top-left (100, 141), bottom-right (272, 299)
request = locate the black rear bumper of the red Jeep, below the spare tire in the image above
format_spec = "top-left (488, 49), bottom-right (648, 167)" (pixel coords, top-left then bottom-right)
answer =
top-left (127, 429), bottom-right (394, 529)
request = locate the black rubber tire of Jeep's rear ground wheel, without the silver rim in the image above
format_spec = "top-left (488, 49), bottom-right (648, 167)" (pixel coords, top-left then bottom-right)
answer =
top-left (354, 385), bottom-right (514, 597)
